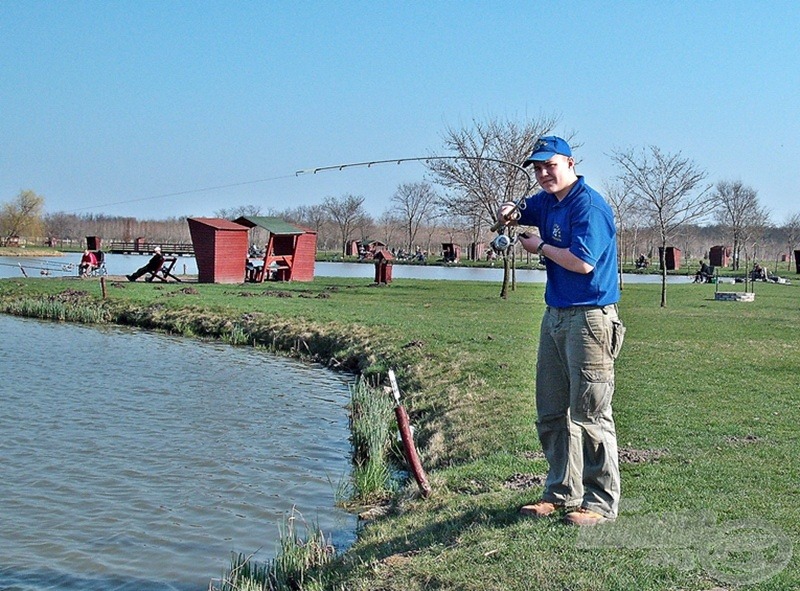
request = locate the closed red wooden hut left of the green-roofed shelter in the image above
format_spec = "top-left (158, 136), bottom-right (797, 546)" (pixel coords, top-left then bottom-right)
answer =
top-left (187, 218), bottom-right (248, 283)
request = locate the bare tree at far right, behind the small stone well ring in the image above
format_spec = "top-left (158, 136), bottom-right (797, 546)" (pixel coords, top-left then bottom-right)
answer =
top-left (714, 181), bottom-right (769, 269)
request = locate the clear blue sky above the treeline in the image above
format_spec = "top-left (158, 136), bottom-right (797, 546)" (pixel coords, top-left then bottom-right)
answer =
top-left (0, 0), bottom-right (800, 223)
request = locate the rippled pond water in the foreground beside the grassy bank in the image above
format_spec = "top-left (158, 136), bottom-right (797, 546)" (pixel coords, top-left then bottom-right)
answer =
top-left (0, 315), bottom-right (356, 591)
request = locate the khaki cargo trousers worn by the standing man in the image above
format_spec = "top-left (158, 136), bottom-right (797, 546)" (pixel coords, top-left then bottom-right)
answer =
top-left (536, 305), bottom-right (625, 519)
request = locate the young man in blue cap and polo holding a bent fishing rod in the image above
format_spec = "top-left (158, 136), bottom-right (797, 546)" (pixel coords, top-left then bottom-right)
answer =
top-left (498, 136), bottom-right (625, 526)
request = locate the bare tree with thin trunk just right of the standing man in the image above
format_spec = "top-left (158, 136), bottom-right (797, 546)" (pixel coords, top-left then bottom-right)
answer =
top-left (611, 146), bottom-right (715, 308)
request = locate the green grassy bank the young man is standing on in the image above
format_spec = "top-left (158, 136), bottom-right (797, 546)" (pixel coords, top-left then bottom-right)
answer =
top-left (0, 275), bottom-right (800, 591)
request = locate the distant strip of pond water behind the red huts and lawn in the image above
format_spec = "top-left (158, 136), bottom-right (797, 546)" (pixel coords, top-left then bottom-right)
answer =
top-left (0, 253), bottom-right (693, 283)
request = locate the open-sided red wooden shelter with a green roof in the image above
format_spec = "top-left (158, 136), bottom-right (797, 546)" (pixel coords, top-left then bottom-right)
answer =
top-left (235, 215), bottom-right (317, 282)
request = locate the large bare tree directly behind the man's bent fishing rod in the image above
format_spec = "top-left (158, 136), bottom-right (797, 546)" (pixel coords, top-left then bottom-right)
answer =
top-left (428, 117), bottom-right (557, 298)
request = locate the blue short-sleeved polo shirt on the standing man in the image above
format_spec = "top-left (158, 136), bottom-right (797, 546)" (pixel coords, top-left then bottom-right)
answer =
top-left (519, 176), bottom-right (620, 308)
